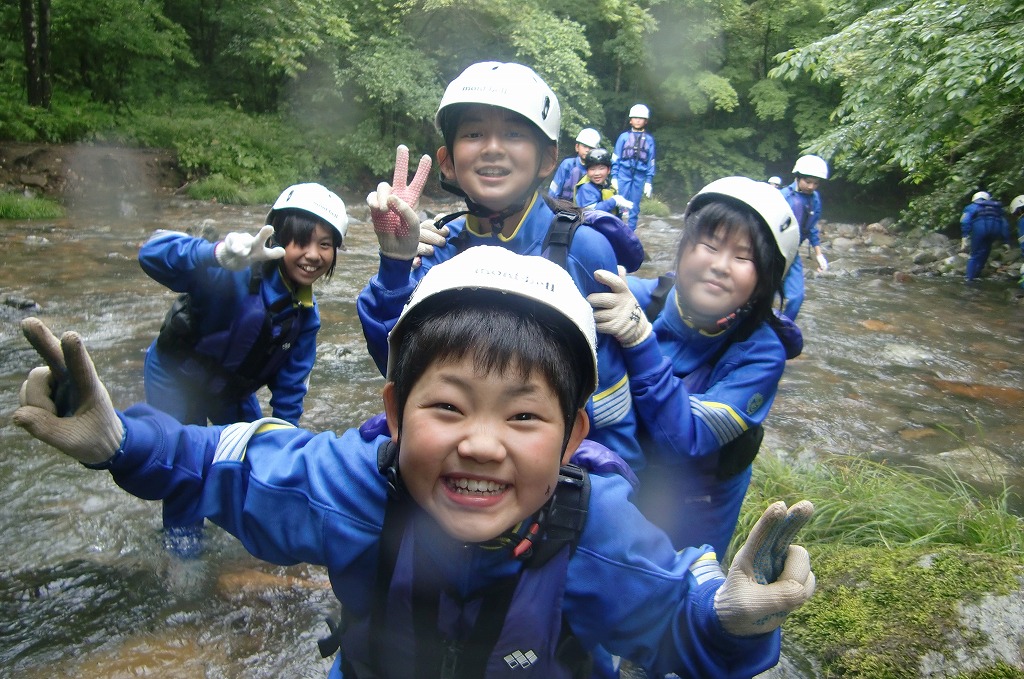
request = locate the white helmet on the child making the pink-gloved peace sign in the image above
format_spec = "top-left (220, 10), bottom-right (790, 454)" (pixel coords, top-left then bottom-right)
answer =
top-left (434, 61), bottom-right (562, 143)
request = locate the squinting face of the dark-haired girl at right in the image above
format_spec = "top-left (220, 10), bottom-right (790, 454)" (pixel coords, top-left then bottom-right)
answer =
top-left (676, 227), bottom-right (758, 331)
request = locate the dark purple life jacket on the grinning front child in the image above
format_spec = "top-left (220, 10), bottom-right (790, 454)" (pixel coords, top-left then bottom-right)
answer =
top-left (321, 436), bottom-right (606, 679)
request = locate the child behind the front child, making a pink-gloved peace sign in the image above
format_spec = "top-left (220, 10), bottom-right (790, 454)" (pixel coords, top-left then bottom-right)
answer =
top-left (356, 61), bottom-right (640, 458)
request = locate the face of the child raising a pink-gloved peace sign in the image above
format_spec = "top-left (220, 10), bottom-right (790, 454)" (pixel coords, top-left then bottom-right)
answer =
top-left (437, 104), bottom-right (558, 212)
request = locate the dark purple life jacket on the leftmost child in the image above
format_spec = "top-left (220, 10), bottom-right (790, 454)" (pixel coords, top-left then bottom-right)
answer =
top-left (157, 264), bottom-right (301, 397)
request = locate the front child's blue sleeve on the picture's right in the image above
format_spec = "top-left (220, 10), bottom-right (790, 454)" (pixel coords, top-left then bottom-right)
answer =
top-left (565, 473), bottom-right (780, 678)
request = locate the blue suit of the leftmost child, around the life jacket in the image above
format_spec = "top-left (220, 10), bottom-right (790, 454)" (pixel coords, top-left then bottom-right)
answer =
top-left (138, 231), bottom-right (321, 540)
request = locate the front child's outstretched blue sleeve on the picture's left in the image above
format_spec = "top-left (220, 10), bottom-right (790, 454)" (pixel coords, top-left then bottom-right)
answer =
top-left (110, 405), bottom-right (385, 569)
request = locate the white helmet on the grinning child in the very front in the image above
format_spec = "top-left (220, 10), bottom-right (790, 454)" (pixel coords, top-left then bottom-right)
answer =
top-left (387, 245), bottom-right (597, 395)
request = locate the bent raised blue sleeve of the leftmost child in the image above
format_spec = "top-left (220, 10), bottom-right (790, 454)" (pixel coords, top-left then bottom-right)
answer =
top-left (138, 230), bottom-right (221, 292)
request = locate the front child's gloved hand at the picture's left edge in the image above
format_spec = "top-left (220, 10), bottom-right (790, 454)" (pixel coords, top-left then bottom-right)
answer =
top-left (12, 317), bottom-right (125, 466)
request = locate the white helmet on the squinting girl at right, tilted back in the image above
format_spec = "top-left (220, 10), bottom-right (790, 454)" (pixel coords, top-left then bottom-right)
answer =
top-left (686, 177), bottom-right (800, 275)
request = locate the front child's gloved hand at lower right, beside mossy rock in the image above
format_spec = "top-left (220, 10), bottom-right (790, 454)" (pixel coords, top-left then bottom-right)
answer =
top-left (715, 500), bottom-right (815, 636)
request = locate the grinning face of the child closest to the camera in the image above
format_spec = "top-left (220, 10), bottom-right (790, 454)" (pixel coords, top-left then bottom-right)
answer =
top-left (384, 357), bottom-right (587, 542)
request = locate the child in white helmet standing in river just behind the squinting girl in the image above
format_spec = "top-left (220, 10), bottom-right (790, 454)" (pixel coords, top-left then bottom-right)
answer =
top-left (781, 156), bottom-right (828, 321)
